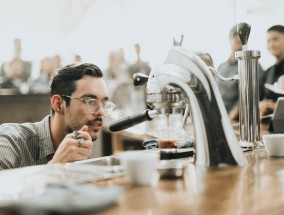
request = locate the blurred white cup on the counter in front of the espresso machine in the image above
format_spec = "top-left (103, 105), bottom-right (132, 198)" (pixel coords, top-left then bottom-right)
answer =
top-left (121, 152), bottom-right (159, 186)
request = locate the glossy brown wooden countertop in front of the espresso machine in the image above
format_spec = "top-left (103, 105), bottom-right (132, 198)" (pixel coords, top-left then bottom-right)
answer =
top-left (96, 149), bottom-right (284, 215)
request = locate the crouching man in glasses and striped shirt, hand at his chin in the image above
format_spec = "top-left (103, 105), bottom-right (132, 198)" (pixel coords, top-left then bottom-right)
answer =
top-left (0, 63), bottom-right (115, 169)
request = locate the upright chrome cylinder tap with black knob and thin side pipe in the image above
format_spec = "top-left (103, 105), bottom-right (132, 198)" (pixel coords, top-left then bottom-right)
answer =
top-left (209, 23), bottom-right (260, 148)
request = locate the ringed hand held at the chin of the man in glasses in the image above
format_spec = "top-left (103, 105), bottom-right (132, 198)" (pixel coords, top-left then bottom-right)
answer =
top-left (49, 125), bottom-right (93, 163)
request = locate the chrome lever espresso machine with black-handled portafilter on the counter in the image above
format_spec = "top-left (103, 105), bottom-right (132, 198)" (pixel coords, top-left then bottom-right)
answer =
top-left (110, 27), bottom-right (247, 167)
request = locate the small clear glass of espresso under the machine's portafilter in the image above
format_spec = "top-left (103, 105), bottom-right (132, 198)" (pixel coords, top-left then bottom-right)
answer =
top-left (158, 127), bottom-right (178, 150)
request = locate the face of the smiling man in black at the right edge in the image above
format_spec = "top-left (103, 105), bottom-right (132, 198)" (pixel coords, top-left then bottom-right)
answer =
top-left (267, 31), bottom-right (284, 57)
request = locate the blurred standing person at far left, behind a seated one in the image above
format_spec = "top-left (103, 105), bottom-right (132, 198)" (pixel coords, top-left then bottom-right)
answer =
top-left (0, 38), bottom-right (32, 83)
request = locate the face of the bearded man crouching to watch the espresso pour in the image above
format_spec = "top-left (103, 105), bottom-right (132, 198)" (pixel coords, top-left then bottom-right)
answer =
top-left (64, 76), bottom-right (108, 140)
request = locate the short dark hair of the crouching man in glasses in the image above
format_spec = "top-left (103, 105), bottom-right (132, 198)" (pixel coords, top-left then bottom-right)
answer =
top-left (50, 63), bottom-right (103, 115)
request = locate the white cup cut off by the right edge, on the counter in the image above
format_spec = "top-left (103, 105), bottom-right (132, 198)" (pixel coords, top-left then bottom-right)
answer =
top-left (262, 134), bottom-right (284, 157)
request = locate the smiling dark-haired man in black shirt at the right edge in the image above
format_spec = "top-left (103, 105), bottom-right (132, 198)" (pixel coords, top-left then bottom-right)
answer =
top-left (259, 25), bottom-right (284, 116)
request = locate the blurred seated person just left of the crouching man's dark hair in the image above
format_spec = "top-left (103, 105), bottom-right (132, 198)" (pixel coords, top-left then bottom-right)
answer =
top-left (30, 57), bottom-right (55, 94)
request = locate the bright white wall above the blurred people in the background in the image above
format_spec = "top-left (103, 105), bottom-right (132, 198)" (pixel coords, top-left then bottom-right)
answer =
top-left (0, 0), bottom-right (284, 72)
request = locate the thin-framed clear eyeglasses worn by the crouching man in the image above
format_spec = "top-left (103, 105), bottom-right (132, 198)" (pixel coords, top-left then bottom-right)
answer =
top-left (61, 95), bottom-right (116, 116)
